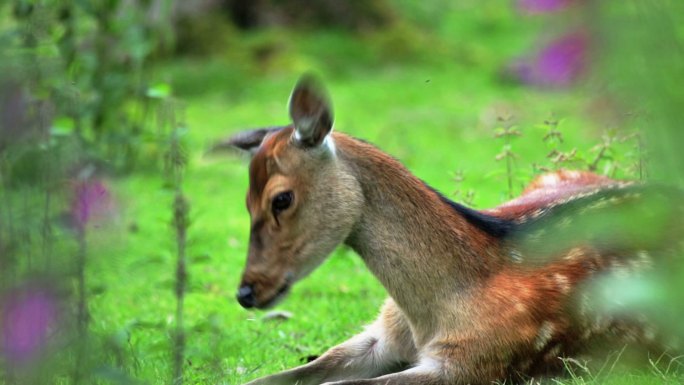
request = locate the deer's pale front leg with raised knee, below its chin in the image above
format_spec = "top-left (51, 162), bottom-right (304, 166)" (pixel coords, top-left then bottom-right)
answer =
top-left (247, 300), bottom-right (415, 385)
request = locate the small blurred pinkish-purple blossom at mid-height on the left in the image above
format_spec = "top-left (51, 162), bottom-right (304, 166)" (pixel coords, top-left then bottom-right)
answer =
top-left (71, 179), bottom-right (113, 229)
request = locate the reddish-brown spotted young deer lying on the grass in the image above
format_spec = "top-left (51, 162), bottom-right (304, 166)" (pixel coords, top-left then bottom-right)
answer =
top-left (224, 76), bottom-right (680, 385)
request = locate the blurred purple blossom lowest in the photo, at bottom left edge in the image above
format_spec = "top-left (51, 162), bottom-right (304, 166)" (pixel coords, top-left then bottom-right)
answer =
top-left (2, 287), bottom-right (58, 364)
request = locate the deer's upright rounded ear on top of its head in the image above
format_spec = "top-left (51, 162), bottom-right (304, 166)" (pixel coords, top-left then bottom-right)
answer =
top-left (290, 75), bottom-right (333, 147)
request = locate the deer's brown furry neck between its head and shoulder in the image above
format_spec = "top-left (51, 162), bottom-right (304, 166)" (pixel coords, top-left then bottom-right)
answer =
top-left (335, 134), bottom-right (508, 332)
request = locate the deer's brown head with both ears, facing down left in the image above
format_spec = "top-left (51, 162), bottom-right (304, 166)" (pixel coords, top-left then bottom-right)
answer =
top-left (228, 76), bottom-right (363, 308)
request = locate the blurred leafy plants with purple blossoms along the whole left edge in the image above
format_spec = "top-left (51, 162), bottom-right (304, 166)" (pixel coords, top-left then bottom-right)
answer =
top-left (0, 0), bottom-right (166, 384)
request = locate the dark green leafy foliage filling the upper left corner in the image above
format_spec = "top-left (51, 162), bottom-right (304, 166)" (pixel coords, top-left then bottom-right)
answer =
top-left (0, 0), bottom-right (173, 170)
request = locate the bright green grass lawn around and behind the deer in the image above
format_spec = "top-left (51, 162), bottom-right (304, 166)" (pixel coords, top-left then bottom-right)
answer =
top-left (52, 2), bottom-right (680, 384)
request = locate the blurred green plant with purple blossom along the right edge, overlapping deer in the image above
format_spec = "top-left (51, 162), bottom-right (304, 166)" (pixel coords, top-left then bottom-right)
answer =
top-left (514, 0), bottom-right (684, 382)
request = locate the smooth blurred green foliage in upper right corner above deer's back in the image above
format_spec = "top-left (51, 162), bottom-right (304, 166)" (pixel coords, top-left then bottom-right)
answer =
top-left (589, 0), bottom-right (684, 184)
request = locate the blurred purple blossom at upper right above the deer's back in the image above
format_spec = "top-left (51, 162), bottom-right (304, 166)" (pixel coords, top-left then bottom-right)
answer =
top-left (508, 31), bottom-right (589, 87)
